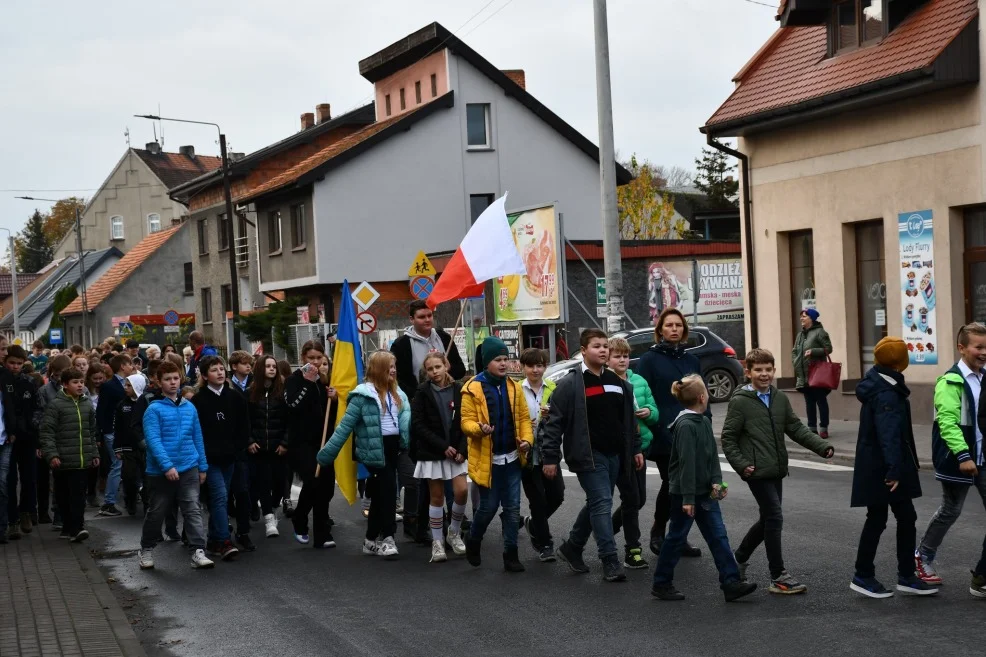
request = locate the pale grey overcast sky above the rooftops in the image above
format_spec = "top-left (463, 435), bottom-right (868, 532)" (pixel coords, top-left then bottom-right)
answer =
top-left (0, 0), bottom-right (777, 246)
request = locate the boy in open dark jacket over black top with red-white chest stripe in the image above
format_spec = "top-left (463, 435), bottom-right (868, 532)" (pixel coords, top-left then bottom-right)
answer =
top-left (540, 329), bottom-right (644, 582)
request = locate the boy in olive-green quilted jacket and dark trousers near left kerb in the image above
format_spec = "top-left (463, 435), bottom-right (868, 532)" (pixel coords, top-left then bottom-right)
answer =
top-left (41, 368), bottom-right (99, 543)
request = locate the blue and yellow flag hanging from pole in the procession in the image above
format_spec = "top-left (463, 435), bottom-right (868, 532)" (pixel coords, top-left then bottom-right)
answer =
top-left (329, 280), bottom-right (363, 504)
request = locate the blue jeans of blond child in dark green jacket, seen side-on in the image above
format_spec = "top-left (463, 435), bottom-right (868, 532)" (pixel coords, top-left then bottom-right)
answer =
top-left (654, 495), bottom-right (739, 588)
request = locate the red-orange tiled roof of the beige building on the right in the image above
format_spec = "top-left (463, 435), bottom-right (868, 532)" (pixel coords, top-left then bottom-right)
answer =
top-left (707, 0), bottom-right (978, 128)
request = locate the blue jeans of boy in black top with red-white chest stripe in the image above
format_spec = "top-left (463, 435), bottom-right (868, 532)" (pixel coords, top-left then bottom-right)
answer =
top-left (558, 450), bottom-right (620, 560)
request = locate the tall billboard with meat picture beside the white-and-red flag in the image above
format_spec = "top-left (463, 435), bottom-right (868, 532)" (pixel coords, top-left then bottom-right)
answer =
top-left (493, 206), bottom-right (561, 322)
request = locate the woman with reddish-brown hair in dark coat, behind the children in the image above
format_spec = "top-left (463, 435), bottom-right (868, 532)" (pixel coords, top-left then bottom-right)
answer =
top-left (637, 308), bottom-right (712, 557)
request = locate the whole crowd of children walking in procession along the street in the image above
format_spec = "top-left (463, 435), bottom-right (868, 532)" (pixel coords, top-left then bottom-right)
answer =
top-left (0, 311), bottom-right (986, 601)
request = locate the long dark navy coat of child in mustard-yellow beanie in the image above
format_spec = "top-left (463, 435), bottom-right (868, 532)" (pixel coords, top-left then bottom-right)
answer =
top-left (850, 365), bottom-right (921, 506)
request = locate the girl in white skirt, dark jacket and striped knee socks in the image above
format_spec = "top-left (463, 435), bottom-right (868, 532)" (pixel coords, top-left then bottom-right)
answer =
top-left (410, 351), bottom-right (469, 562)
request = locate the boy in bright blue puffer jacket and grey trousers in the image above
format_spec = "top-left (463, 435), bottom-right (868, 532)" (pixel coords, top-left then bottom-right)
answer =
top-left (138, 361), bottom-right (213, 569)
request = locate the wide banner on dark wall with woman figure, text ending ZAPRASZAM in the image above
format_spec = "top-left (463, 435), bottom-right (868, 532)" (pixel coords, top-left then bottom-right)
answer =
top-left (647, 259), bottom-right (743, 324)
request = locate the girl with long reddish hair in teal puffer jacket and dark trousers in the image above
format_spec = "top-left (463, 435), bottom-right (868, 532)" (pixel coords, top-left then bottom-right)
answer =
top-left (317, 351), bottom-right (411, 559)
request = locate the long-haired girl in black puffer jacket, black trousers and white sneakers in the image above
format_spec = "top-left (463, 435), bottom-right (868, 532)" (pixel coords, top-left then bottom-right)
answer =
top-left (247, 354), bottom-right (288, 538)
